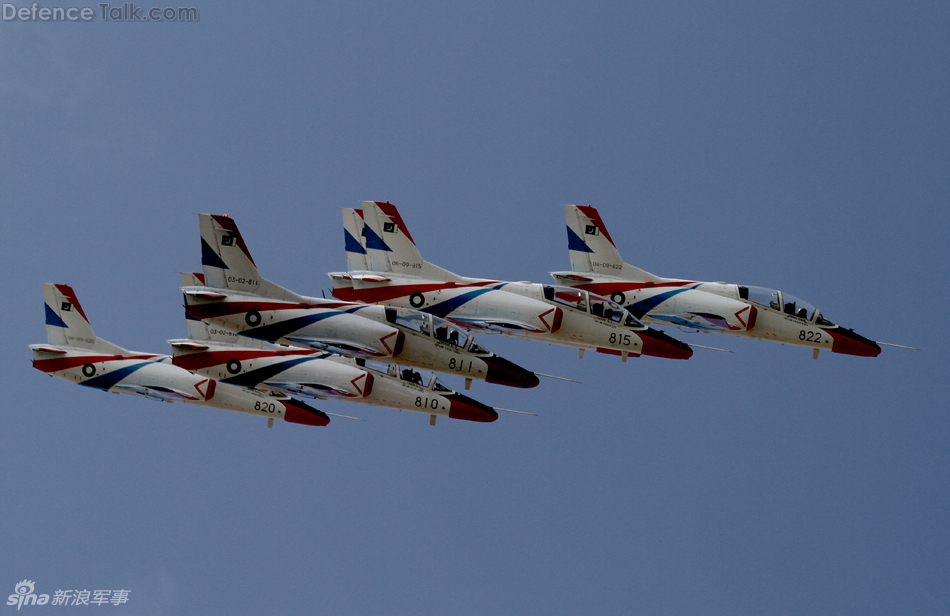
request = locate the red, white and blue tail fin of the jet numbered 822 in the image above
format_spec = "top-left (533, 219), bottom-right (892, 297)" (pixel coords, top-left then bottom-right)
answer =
top-left (564, 205), bottom-right (660, 281)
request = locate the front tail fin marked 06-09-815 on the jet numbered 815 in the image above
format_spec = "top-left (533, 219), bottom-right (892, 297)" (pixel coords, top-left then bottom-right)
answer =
top-left (363, 201), bottom-right (423, 275)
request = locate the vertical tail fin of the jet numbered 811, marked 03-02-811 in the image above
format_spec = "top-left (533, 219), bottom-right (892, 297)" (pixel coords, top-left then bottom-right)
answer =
top-left (198, 214), bottom-right (302, 301)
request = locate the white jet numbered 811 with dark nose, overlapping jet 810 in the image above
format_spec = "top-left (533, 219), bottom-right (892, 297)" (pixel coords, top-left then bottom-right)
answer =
top-left (182, 214), bottom-right (538, 389)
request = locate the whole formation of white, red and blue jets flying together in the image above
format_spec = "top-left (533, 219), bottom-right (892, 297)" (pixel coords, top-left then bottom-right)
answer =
top-left (30, 201), bottom-right (898, 426)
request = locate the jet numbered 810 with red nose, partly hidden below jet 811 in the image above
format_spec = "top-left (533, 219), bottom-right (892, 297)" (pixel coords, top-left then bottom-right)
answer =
top-left (168, 312), bottom-right (498, 422)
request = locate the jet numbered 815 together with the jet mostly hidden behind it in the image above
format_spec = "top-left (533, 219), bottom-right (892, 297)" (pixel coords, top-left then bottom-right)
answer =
top-left (329, 201), bottom-right (692, 361)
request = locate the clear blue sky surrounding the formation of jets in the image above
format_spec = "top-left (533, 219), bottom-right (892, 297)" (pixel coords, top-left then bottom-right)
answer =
top-left (0, 2), bottom-right (950, 616)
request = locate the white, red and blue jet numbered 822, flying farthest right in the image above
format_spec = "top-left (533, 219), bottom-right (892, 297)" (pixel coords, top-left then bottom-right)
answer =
top-left (551, 205), bottom-right (884, 359)
